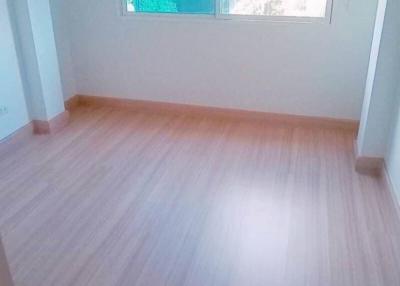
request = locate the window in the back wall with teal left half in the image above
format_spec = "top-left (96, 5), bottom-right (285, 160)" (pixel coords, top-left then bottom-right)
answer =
top-left (123, 0), bottom-right (332, 20)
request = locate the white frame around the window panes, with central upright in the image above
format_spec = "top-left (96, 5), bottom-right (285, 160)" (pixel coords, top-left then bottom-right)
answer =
top-left (118, 0), bottom-right (334, 24)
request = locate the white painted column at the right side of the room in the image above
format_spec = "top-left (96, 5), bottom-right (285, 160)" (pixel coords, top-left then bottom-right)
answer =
top-left (357, 0), bottom-right (400, 166)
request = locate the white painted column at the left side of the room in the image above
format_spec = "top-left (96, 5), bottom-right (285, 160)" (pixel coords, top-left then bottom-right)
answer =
top-left (13, 0), bottom-right (65, 125)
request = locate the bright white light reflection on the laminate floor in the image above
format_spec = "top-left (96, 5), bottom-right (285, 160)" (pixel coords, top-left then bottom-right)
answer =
top-left (189, 180), bottom-right (289, 285)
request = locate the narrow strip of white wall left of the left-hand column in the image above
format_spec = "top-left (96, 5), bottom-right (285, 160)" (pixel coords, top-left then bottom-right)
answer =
top-left (0, 0), bottom-right (29, 140)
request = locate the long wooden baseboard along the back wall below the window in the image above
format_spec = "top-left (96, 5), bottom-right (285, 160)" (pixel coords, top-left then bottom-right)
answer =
top-left (66, 95), bottom-right (359, 133)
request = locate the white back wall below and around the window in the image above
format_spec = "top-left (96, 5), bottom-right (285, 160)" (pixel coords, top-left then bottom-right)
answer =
top-left (60, 0), bottom-right (377, 119)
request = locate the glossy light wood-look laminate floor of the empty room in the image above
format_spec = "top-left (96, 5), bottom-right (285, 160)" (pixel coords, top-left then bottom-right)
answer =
top-left (0, 107), bottom-right (400, 286)
